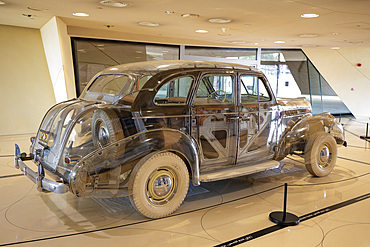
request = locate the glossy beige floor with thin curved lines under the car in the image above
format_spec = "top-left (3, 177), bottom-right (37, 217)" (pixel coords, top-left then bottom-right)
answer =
top-left (0, 118), bottom-right (370, 247)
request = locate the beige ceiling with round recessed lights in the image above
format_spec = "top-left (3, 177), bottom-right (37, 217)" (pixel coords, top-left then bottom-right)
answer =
top-left (0, 0), bottom-right (370, 48)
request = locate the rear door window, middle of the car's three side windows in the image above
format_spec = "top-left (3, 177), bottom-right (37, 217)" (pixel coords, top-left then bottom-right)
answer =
top-left (194, 75), bottom-right (234, 105)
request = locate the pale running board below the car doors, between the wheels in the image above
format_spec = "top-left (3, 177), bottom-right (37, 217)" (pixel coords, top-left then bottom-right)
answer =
top-left (200, 160), bottom-right (280, 182)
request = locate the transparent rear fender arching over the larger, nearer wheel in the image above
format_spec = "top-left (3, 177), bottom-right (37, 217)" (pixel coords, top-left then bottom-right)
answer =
top-left (69, 129), bottom-right (200, 196)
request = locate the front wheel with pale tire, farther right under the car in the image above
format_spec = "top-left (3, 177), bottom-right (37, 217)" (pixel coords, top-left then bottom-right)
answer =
top-left (304, 132), bottom-right (337, 177)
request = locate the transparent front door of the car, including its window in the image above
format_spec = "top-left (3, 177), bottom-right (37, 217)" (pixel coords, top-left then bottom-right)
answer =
top-left (237, 74), bottom-right (276, 164)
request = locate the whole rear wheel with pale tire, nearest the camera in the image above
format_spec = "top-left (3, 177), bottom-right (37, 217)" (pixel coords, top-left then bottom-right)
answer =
top-left (128, 152), bottom-right (189, 219)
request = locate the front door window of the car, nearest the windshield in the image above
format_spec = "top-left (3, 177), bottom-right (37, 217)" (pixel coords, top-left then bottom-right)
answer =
top-left (240, 75), bottom-right (271, 104)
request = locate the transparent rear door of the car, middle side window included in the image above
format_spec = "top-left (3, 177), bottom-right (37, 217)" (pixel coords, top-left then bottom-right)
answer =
top-left (191, 73), bottom-right (238, 171)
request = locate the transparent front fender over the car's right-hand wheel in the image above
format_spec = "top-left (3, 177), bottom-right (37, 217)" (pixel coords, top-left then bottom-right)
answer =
top-left (275, 113), bottom-right (345, 160)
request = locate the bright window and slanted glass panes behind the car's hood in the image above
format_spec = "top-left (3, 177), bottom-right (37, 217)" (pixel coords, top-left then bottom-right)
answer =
top-left (260, 49), bottom-right (351, 114)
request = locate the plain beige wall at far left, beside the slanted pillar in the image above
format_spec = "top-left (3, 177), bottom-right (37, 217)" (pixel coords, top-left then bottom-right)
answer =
top-left (0, 25), bottom-right (55, 135)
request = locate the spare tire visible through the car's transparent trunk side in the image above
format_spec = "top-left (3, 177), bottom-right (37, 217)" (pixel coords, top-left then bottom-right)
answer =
top-left (91, 110), bottom-right (124, 148)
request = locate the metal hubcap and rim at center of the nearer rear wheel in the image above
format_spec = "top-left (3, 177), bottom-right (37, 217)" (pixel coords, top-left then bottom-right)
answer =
top-left (147, 168), bottom-right (177, 205)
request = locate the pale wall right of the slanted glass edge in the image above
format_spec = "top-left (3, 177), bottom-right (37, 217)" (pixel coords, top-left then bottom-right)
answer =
top-left (304, 48), bottom-right (370, 119)
